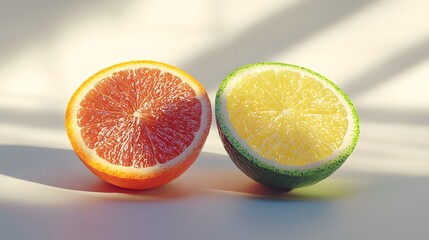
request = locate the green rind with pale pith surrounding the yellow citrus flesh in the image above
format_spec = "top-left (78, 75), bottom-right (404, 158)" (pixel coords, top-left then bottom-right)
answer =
top-left (215, 62), bottom-right (360, 189)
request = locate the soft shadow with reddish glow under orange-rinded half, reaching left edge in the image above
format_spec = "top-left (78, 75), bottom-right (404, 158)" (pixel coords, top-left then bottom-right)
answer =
top-left (0, 145), bottom-right (203, 200)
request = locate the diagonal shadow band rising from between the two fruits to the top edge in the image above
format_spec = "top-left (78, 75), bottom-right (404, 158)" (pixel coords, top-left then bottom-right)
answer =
top-left (181, 0), bottom-right (375, 90)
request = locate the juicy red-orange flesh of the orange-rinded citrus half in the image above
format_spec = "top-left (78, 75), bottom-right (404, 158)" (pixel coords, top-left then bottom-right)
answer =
top-left (77, 68), bottom-right (202, 168)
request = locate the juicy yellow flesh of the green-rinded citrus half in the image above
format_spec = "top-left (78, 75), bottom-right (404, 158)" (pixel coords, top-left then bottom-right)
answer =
top-left (226, 70), bottom-right (349, 166)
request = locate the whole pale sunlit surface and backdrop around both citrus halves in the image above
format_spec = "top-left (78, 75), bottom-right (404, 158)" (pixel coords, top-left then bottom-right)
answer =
top-left (0, 0), bottom-right (429, 240)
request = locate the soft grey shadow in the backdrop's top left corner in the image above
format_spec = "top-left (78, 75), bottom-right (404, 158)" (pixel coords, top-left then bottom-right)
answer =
top-left (0, 0), bottom-right (133, 62)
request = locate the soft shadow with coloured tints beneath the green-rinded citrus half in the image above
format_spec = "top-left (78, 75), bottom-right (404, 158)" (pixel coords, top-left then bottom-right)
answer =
top-left (180, 152), bottom-right (356, 200)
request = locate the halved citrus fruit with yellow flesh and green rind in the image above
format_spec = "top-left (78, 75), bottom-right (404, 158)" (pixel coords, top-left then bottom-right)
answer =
top-left (215, 62), bottom-right (359, 189)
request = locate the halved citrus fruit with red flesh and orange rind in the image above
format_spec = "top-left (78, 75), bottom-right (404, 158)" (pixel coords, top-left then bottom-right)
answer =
top-left (66, 61), bottom-right (212, 189)
